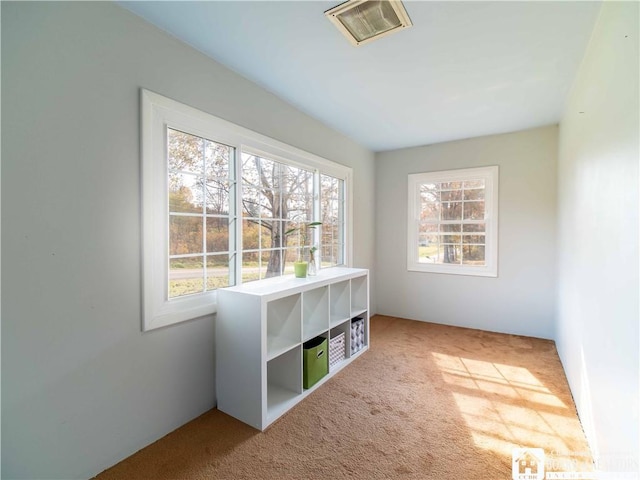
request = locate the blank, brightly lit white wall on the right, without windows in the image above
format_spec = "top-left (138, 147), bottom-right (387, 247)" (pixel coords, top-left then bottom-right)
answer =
top-left (557, 2), bottom-right (640, 478)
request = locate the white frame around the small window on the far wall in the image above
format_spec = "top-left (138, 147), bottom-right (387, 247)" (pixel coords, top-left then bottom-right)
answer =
top-left (407, 166), bottom-right (499, 277)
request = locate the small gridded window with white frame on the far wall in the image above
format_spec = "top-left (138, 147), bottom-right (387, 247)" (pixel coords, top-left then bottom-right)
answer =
top-left (407, 166), bottom-right (498, 277)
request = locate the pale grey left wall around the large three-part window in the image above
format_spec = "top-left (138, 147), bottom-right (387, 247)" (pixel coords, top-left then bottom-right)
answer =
top-left (2, 2), bottom-right (374, 479)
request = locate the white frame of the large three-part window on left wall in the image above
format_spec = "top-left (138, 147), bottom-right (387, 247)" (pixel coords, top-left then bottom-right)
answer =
top-left (140, 89), bottom-right (353, 331)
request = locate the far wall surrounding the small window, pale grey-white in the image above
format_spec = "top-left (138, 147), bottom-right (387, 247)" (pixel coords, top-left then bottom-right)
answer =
top-left (376, 126), bottom-right (558, 338)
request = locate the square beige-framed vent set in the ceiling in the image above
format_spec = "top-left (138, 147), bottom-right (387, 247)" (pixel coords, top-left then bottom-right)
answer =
top-left (324, 0), bottom-right (413, 47)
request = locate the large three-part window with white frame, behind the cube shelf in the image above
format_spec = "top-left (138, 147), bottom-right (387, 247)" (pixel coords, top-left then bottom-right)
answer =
top-left (142, 90), bottom-right (351, 330)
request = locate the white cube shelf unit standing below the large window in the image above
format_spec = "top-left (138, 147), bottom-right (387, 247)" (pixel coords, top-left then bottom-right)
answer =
top-left (216, 267), bottom-right (369, 430)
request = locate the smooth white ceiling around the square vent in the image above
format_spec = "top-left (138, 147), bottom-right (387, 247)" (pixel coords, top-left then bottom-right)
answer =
top-left (120, 0), bottom-right (600, 151)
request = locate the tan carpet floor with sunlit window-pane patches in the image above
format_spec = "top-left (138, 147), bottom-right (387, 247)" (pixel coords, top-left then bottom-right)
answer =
top-left (96, 316), bottom-right (590, 480)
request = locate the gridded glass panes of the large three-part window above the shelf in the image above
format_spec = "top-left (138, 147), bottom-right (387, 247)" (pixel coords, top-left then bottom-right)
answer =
top-left (167, 128), bottom-right (345, 292)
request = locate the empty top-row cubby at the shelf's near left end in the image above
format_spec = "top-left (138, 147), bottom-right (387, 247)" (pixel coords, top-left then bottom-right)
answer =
top-left (267, 294), bottom-right (302, 359)
